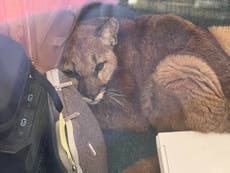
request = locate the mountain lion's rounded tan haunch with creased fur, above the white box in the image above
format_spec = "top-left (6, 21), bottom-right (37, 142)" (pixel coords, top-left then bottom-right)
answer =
top-left (146, 55), bottom-right (230, 132)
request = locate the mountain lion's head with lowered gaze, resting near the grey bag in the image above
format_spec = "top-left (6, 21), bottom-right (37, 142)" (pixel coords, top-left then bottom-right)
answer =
top-left (63, 18), bottom-right (119, 104)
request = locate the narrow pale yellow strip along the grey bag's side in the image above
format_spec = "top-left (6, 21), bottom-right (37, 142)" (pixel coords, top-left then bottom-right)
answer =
top-left (59, 113), bottom-right (75, 165)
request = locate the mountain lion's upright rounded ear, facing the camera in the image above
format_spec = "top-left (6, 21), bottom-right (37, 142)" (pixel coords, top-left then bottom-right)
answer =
top-left (97, 18), bottom-right (119, 46)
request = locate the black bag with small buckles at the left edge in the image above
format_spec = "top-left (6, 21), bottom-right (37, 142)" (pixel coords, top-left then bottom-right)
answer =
top-left (0, 35), bottom-right (63, 173)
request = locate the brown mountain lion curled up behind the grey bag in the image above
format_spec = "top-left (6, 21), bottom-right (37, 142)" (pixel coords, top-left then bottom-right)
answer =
top-left (63, 14), bottom-right (230, 172)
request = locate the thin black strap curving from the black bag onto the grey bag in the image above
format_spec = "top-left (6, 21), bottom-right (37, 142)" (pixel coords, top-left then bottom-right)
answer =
top-left (30, 65), bottom-right (63, 112)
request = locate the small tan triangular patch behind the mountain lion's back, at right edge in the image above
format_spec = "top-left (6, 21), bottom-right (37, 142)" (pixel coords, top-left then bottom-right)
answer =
top-left (209, 26), bottom-right (230, 56)
